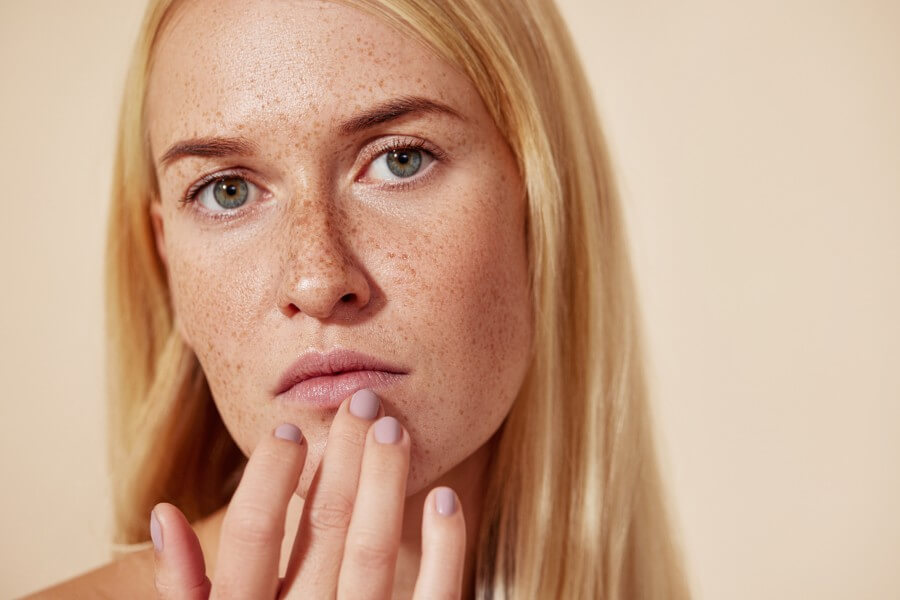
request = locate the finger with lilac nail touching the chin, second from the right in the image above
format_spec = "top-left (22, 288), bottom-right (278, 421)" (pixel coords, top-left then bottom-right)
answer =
top-left (338, 417), bottom-right (410, 599)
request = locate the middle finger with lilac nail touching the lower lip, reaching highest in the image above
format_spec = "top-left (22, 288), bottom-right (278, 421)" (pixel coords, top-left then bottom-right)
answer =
top-left (284, 390), bottom-right (383, 598)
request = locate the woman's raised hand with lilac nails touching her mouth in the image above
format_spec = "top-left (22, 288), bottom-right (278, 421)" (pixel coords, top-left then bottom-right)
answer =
top-left (151, 390), bottom-right (466, 600)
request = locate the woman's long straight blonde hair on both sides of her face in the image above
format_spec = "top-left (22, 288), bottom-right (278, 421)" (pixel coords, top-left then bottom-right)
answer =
top-left (107, 0), bottom-right (689, 599)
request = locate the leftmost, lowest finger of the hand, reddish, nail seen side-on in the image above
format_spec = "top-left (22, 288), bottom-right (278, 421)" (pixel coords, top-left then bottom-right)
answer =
top-left (150, 502), bottom-right (210, 600)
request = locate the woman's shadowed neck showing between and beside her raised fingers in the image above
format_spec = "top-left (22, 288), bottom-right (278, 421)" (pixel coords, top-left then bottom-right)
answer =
top-left (194, 435), bottom-right (497, 599)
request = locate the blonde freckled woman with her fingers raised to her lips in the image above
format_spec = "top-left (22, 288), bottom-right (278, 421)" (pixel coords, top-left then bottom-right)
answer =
top-left (33, 0), bottom-right (687, 598)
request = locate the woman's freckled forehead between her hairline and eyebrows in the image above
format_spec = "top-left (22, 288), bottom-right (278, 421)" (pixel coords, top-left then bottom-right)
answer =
top-left (147, 0), bottom-right (472, 153)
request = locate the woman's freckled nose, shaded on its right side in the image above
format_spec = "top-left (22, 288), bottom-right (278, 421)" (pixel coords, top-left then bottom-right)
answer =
top-left (278, 203), bottom-right (371, 321)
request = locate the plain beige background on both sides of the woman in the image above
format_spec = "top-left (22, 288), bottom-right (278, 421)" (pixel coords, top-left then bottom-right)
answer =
top-left (0, 0), bottom-right (900, 600)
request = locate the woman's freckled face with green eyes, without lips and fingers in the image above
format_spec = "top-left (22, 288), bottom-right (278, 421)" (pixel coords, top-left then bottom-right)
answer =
top-left (147, 0), bottom-right (532, 494)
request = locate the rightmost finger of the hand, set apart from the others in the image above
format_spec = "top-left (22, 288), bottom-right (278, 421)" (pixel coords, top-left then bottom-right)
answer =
top-left (413, 487), bottom-right (466, 600)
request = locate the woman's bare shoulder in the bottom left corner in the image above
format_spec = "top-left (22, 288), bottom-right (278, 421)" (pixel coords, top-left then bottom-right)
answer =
top-left (26, 548), bottom-right (156, 600)
